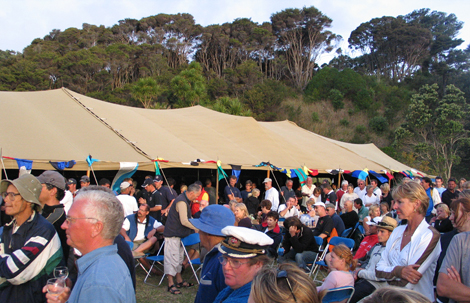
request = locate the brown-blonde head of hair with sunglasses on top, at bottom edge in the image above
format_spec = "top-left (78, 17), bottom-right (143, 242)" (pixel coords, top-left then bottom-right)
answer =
top-left (248, 263), bottom-right (320, 303)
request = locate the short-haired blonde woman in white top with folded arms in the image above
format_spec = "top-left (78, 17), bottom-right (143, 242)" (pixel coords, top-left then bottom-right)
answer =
top-left (376, 182), bottom-right (441, 302)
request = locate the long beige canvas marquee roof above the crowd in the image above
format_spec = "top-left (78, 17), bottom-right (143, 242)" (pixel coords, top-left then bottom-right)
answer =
top-left (0, 89), bottom-right (426, 176)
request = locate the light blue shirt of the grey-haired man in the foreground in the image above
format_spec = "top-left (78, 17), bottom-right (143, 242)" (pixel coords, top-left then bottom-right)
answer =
top-left (67, 244), bottom-right (135, 303)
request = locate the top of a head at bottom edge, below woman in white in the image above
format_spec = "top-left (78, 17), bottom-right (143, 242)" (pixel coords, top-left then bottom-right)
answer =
top-left (362, 286), bottom-right (431, 303)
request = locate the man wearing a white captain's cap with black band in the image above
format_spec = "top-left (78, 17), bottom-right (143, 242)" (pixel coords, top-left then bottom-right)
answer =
top-left (214, 226), bottom-right (273, 303)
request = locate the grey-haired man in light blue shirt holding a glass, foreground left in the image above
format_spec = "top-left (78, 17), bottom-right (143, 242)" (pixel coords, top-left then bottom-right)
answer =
top-left (43, 186), bottom-right (135, 303)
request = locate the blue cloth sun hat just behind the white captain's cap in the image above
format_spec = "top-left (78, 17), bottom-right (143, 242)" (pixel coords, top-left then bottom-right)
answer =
top-left (189, 205), bottom-right (235, 237)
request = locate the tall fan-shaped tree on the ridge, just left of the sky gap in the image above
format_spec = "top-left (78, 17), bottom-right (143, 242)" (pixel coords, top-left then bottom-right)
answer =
top-left (271, 6), bottom-right (340, 90)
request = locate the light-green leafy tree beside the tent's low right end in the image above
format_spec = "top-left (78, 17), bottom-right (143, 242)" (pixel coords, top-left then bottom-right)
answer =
top-left (395, 84), bottom-right (468, 179)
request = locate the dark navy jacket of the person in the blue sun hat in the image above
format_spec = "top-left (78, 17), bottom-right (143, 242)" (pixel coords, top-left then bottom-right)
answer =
top-left (194, 244), bottom-right (227, 303)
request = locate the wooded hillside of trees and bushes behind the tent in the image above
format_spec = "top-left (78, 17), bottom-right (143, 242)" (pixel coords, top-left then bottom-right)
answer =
top-left (0, 6), bottom-right (470, 177)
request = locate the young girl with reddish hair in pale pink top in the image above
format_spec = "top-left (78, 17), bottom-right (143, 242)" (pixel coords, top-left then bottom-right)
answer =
top-left (317, 244), bottom-right (357, 292)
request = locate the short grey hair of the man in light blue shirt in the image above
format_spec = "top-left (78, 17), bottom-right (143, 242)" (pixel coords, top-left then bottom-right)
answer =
top-left (75, 185), bottom-right (124, 239)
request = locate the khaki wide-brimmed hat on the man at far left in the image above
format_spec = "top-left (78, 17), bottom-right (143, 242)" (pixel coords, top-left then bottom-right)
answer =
top-left (0, 174), bottom-right (42, 206)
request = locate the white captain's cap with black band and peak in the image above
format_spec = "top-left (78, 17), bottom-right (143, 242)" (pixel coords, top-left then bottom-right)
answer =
top-left (219, 226), bottom-right (274, 259)
